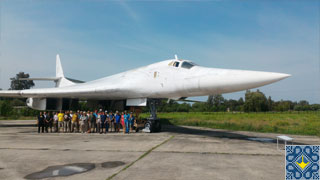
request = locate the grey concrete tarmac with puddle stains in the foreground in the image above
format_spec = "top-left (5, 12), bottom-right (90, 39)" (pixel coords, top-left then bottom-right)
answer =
top-left (0, 120), bottom-right (320, 180)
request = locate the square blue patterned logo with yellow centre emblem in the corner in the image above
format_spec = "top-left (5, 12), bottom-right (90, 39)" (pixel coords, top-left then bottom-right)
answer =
top-left (286, 145), bottom-right (320, 180)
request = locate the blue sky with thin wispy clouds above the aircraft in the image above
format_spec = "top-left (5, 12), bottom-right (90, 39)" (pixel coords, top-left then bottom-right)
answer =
top-left (0, 0), bottom-right (320, 103)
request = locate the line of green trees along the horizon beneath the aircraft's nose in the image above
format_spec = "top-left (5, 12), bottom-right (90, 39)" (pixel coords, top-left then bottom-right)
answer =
top-left (158, 90), bottom-right (320, 112)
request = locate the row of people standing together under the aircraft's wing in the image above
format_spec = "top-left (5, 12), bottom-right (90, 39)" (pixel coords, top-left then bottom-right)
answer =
top-left (37, 109), bottom-right (135, 134)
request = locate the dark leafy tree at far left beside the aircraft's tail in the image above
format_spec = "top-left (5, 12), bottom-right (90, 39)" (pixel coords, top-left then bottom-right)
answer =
top-left (9, 72), bottom-right (34, 90)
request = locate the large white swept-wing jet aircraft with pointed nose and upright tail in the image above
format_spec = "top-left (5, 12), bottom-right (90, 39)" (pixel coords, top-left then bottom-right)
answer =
top-left (0, 55), bottom-right (290, 131)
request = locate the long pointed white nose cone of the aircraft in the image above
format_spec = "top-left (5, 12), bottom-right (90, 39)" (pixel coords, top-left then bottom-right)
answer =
top-left (199, 69), bottom-right (291, 94)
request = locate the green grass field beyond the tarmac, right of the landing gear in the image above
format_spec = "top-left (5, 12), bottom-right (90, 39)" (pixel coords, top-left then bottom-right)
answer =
top-left (141, 111), bottom-right (320, 136)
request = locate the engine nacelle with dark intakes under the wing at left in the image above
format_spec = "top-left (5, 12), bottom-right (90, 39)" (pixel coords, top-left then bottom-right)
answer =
top-left (27, 98), bottom-right (78, 111)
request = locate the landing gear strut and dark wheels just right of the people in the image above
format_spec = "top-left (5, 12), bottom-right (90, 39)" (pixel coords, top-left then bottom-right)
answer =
top-left (142, 99), bottom-right (161, 133)
